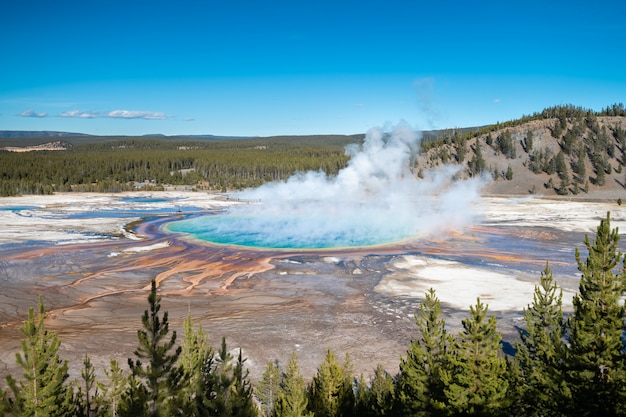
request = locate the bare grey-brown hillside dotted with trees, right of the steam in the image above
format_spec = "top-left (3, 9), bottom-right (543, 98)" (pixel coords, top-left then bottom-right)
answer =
top-left (416, 104), bottom-right (626, 195)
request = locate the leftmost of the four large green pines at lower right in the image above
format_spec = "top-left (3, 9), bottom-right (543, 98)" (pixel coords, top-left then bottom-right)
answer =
top-left (397, 288), bottom-right (452, 416)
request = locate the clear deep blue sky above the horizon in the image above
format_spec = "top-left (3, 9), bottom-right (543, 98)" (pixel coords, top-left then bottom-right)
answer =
top-left (0, 0), bottom-right (626, 136)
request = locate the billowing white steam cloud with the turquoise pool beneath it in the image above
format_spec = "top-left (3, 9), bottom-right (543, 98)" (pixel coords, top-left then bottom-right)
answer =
top-left (175, 124), bottom-right (485, 248)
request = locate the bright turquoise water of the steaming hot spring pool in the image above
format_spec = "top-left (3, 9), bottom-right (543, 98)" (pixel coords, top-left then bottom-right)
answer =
top-left (166, 214), bottom-right (414, 249)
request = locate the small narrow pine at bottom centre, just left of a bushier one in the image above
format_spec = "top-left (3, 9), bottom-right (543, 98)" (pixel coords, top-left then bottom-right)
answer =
top-left (275, 352), bottom-right (313, 417)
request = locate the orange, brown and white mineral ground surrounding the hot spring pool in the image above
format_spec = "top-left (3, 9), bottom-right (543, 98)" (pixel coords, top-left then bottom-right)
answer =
top-left (0, 192), bottom-right (626, 379)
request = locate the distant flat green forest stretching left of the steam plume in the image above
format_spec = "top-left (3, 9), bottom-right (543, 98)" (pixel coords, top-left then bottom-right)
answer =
top-left (0, 135), bottom-right (363, 196)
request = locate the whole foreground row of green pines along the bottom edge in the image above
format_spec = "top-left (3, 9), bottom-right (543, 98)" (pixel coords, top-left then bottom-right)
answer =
top-left (0, 214), bottom-right (626, 417)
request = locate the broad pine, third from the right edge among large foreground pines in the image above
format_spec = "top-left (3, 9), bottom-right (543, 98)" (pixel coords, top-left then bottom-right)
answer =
top-left (443, 299), bottom-right (508, 416)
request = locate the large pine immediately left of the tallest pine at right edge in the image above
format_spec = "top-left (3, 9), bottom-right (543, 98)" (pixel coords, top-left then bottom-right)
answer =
top-left (515, 263), bottom-right (571, 416)
